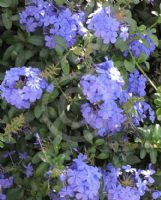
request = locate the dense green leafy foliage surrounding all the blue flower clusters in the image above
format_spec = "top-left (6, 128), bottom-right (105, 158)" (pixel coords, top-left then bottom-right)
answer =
top-left (0, 0), bottom-right (161, 200)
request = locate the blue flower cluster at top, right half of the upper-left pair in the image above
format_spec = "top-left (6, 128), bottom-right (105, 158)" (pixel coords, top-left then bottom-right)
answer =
top-left (44, 8), bottom-right (85, 49)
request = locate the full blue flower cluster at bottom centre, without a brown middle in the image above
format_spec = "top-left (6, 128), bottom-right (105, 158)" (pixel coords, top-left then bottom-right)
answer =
top-left (60, 154), bottom-right (102, 200)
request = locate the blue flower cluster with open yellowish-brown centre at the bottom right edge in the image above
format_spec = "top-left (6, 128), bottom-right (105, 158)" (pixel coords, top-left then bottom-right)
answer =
top-left (103, 164), bottom-right (155, 200)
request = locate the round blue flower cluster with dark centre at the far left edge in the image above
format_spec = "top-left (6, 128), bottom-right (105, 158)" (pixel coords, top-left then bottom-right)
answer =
top-left (0, 67), bottom-right (53, 109)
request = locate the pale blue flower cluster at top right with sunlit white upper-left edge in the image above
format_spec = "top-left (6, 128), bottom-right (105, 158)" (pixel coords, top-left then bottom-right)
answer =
top-left (87, 7), bottom-right (129, 44)
